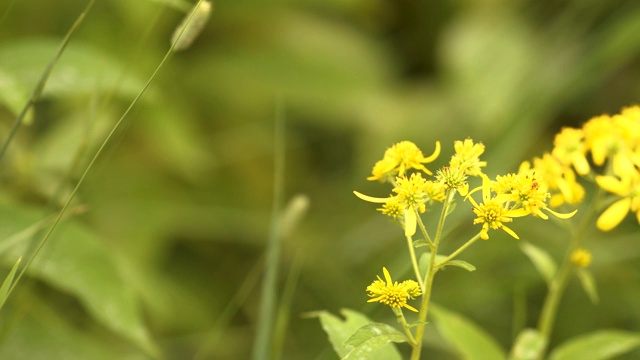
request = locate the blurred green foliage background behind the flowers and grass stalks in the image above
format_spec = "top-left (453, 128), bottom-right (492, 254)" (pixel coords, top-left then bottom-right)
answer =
top-left (0, 0), bottom-right (640, 359)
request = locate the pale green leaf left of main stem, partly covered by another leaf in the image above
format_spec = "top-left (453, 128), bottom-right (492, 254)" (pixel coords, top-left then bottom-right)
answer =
top-left (312, 309), bottom-right (402, 360)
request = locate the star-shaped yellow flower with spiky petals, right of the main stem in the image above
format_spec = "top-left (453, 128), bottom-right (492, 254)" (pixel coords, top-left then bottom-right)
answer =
top-left (467, 175), bottom-right (528, 240)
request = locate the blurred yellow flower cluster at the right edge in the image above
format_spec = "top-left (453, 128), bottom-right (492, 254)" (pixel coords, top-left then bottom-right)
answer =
top-left (525, 106), bottom-right (640, 231)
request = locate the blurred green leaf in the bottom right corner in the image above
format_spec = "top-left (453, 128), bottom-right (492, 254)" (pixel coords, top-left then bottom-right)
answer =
top-left (549, 330), bottom-right (640, 360)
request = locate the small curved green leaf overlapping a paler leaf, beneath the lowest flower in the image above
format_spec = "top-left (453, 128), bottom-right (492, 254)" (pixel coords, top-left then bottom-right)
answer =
top-left (342, 323), bottom-right (407, 360)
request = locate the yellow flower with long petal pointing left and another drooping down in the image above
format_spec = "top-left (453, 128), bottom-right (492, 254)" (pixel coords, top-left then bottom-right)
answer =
top-left (353, 173), bottom-right (442, 236)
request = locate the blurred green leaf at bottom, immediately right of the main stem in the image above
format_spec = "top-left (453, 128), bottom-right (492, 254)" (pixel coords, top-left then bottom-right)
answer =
top-left (431, 304), bottom-right (506, 360)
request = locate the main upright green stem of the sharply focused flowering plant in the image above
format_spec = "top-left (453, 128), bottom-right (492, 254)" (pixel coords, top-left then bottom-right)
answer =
top-left (411, 190), bottom-right (455, 360)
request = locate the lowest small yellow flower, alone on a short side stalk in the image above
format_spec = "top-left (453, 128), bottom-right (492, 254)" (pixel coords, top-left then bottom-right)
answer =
top-left (367, 267), bottom-right (421, 312)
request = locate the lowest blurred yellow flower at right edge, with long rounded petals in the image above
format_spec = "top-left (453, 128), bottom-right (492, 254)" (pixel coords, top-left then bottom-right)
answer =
top-left (596, 170), bottom-right (640, 231)
